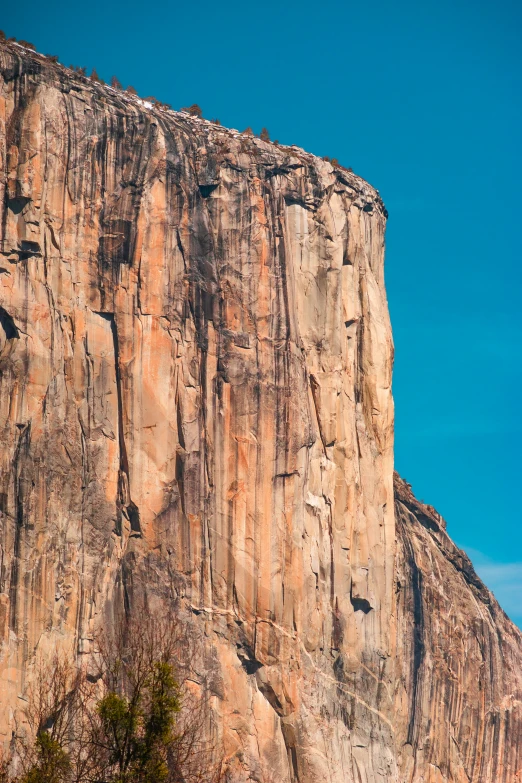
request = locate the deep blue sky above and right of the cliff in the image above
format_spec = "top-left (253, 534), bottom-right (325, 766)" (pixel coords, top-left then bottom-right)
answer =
top-left (0, 0), bottom-right (522, 626)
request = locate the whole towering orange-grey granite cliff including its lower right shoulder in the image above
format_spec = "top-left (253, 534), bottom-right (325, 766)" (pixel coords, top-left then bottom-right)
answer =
top-left (0, 44), bottom-right (522, 783)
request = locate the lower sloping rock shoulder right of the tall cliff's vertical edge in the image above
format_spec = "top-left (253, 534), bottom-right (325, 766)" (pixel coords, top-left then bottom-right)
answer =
top-left (395, 475), bottom-right (522, 783)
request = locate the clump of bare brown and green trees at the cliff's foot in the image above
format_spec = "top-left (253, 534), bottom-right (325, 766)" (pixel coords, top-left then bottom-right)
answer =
top-left (4, 618), bottom-right (222, 783)
